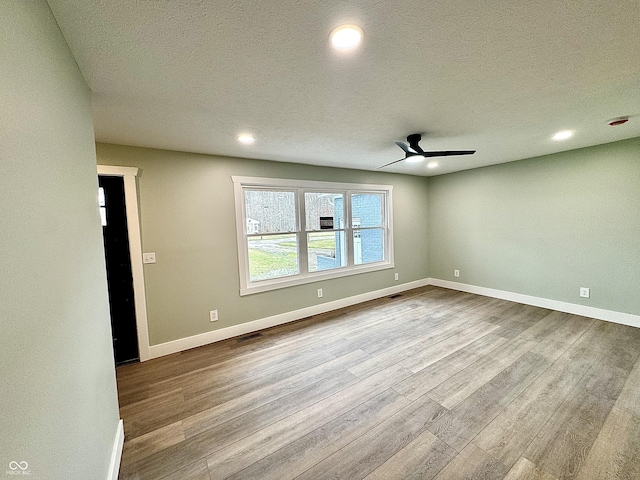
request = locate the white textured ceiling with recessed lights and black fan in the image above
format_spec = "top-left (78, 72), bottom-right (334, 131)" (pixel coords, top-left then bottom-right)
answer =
top-left (48, 0), bottom-right (640, 175)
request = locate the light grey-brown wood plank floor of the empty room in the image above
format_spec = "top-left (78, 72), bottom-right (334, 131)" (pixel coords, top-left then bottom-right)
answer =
top-left (117, 287), bottom-right (640, 480)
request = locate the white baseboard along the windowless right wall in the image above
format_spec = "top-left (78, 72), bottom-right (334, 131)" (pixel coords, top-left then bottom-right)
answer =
top-left (428, 278), bottom-right (640, 328)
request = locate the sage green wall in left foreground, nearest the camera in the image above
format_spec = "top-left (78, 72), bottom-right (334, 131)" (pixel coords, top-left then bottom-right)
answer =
top-left (0, 0), bottom-right (119, 480)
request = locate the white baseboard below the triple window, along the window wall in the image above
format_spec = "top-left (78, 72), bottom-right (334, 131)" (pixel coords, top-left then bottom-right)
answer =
top-left (149, 279), bottom-right (429, 358)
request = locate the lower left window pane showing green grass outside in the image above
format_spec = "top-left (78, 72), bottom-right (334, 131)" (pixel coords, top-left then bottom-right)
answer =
top-left (247, 234), bottom-right (299, 282)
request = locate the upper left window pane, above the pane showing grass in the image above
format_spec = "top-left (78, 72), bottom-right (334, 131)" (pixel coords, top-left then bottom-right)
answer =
top-left (244, 190), bottom-right (297, 234)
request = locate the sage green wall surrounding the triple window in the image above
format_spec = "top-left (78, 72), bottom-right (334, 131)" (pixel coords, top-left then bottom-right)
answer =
top-left (97, 144), bottom-right (428, 345)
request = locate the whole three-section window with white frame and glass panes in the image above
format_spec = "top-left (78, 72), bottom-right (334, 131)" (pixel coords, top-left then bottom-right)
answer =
top-left (232, 177), bottom-right (393, 295)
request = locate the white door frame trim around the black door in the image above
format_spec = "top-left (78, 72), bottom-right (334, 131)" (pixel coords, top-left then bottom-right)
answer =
top-left (98, 165), bottom-right (151, 362)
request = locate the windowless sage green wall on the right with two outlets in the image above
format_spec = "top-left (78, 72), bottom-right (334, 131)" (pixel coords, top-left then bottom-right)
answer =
top-left (428, 138), bottom-right (640, 314)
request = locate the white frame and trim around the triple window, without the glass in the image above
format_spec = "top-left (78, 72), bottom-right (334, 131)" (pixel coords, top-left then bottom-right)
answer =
top-left (231, 175), bottom-right (394, 296)
